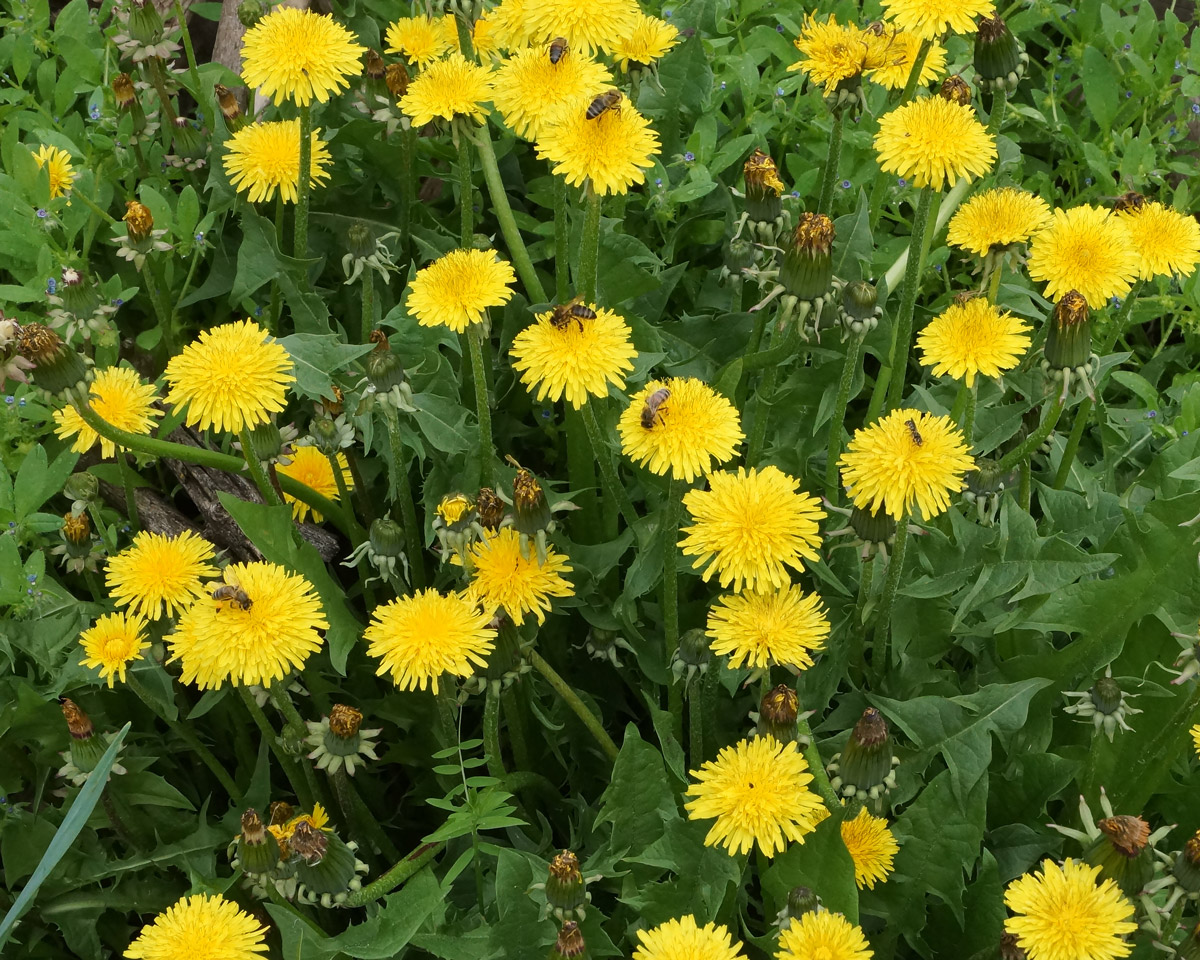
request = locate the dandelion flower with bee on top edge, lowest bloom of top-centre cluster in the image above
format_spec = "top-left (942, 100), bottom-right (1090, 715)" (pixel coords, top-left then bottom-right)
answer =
top-left (538, 90), bottom-right (662, 197)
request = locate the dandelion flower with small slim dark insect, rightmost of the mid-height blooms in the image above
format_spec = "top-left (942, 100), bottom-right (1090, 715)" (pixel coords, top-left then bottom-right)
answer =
top-left (838, 410), bottom-right (974, 520)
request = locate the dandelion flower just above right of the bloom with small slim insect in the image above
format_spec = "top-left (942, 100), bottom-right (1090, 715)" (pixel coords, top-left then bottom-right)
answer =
top-left (917, 296), bottom-right (1031, 386)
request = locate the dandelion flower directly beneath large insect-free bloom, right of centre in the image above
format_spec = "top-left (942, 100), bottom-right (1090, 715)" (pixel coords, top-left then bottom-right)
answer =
top-left (706, 583), bottom-right (829, 671)
